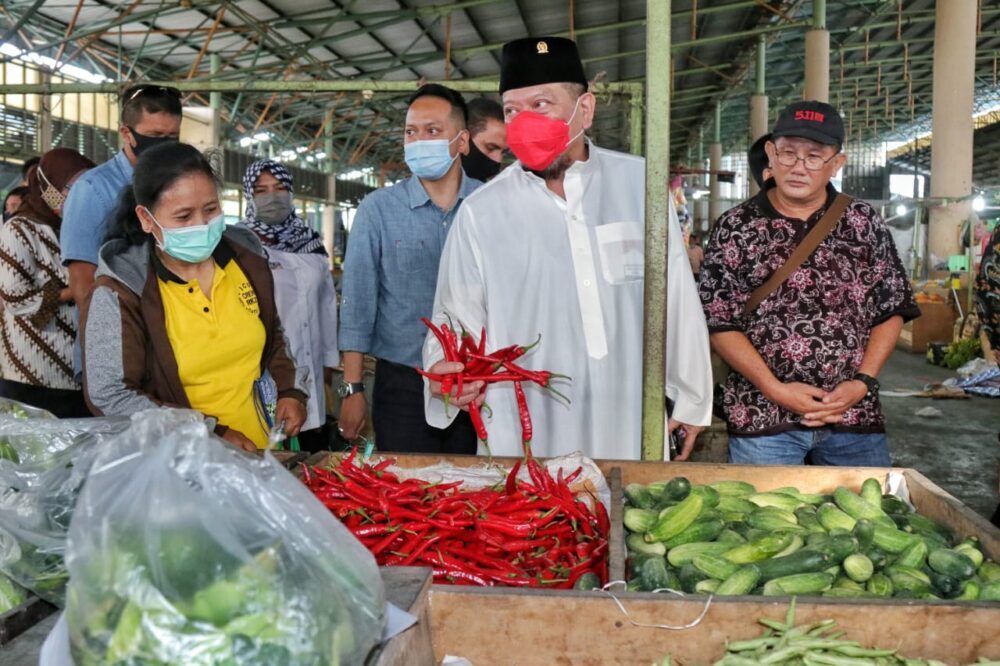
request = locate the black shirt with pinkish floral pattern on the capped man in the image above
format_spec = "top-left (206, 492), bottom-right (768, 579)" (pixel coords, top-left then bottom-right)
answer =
top-left (700, 181), bottom-right (920, 436)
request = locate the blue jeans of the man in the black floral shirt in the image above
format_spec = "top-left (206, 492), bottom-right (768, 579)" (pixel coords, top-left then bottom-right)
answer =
top-left (729, 428), bottom-right (892, 467)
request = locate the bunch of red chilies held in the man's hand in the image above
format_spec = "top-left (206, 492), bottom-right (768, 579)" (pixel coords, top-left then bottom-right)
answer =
top-left (417, 317), bottom-right (569, 453)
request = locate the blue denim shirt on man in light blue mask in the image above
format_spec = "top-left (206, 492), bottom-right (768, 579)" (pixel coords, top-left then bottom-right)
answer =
top-left (338, 173), bottom-right (482, 366)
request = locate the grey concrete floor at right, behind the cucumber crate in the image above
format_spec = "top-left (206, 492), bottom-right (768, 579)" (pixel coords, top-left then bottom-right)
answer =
top-left (879, 350), bottom-right (1000, 518)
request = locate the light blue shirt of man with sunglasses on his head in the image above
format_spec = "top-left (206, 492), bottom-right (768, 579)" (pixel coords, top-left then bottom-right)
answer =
top-left (59, 151), bottom-right (133, 266)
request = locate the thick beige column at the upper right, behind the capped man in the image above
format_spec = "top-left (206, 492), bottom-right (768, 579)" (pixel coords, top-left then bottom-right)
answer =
top-left (928, 0), bottom-right (977, 260)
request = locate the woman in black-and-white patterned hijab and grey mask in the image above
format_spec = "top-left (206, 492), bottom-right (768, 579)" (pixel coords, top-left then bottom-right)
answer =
top-left (241, 160), bottom-right (340, 451)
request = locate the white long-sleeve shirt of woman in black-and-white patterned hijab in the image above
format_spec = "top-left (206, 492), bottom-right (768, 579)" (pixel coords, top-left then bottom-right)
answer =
top-left (266, 247), bottom-right (340, 430)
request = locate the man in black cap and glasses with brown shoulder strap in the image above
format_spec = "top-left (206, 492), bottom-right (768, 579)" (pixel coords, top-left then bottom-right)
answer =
top-left (700, 101), bottom-right (920, 466)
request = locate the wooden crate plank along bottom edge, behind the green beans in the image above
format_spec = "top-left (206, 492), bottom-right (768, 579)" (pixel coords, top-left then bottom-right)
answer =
top-left (431, 586), bottom-right (1000, 666)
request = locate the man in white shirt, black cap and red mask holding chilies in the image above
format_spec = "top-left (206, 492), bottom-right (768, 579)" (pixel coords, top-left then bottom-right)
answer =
top-left (423, 37), bottom-right (712, 459)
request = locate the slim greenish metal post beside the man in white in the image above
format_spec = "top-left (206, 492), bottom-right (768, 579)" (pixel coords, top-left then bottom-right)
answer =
top-left (633, 0), bottom-right (672, 460)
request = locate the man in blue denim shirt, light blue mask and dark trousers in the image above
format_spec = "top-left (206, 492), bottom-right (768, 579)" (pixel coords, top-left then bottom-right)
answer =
top-left (338, 84), bottom-right (481, 454)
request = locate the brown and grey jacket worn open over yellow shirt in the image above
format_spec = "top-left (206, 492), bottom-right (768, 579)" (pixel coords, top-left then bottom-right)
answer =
top-left (80, 227), bottom-right (307, 435)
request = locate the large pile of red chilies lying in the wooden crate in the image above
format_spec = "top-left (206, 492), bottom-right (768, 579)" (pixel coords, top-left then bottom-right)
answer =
top-left (303, 448), bottom-right (610, 588)
